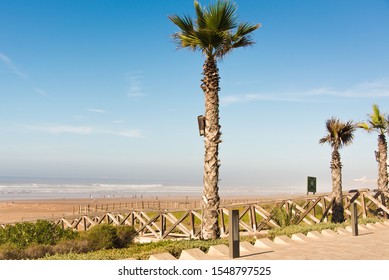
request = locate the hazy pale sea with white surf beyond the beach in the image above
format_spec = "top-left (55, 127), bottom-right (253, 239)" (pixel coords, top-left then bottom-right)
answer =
top-left (0, 177), bottom-right (305, 201)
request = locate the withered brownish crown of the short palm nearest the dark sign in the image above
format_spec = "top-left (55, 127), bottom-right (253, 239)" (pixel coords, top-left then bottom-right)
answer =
top-left (319, 118), bottom-right (355, 149)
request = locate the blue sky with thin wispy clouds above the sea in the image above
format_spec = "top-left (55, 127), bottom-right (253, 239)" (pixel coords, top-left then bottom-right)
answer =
top-left (0, 0), bottom-right (389, 191)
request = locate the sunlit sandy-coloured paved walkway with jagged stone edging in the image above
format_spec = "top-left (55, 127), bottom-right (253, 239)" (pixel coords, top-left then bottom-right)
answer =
top-left (150, 221), bottom-right (389, 260)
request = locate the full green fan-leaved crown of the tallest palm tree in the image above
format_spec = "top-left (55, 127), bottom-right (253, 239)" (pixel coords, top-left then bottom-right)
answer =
top-left (169, 0), bottom-right (260, 58)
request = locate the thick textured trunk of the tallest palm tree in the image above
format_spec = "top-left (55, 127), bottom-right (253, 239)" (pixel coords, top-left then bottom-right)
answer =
top-left (201, 57), bottom-right (221, 239)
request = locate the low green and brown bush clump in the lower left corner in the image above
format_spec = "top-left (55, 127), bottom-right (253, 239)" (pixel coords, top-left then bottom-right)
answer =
top-left (0, 220), bottom-right (136, 260)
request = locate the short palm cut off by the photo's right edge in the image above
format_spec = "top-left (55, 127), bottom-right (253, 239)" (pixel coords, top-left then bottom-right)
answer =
top-left (358, 104), bottom-right (389, 190)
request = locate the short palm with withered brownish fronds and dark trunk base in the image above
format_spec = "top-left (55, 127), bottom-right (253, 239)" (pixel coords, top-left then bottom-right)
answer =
top-left (319, 117), bottom-right (355, 223)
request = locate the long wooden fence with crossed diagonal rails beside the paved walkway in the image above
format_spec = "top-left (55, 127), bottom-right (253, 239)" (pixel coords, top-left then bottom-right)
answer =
top-left (52, 189), bottom-right (389, 240)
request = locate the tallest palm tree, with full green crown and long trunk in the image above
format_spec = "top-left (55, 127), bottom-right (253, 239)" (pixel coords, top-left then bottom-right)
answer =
top-left (169, 0), bottom-right (260, 239)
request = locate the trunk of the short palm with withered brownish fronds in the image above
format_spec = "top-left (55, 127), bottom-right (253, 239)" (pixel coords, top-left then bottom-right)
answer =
top-left (331, 148), bottom-right (344, 223)
